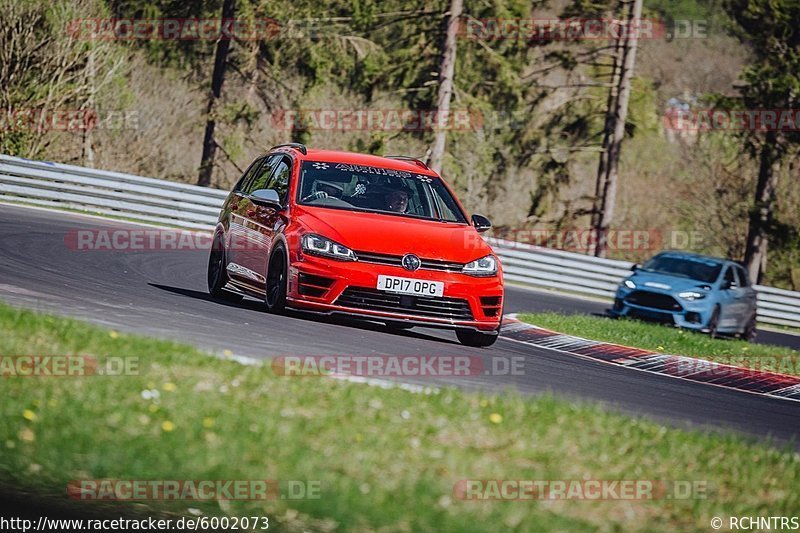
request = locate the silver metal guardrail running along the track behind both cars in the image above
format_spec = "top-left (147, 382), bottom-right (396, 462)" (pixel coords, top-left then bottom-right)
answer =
top-left (0, 155), bottom-right (800, 327)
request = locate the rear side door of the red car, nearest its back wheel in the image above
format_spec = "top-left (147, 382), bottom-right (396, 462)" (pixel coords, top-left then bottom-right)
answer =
top-left (228, 155), bottom-right (281, 288)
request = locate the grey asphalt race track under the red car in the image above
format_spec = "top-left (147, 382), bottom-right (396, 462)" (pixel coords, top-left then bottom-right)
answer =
top-left (0, 204), bottom-right (800, 445)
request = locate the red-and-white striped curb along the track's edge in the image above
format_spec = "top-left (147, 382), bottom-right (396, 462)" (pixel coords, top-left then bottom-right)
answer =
top-left (501, 314), bottom-right (800, 402)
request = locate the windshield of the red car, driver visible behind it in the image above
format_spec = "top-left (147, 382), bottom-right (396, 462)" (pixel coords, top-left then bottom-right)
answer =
top-left (298, 161), bottom-right (466, 223)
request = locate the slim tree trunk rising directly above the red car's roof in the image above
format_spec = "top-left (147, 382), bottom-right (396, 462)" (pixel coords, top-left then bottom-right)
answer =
top-left (428, 0), bottom-right (464, 174)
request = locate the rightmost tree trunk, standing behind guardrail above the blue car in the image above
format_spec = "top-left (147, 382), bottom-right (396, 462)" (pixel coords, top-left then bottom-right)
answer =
top-left (744, 131), bottom-right (780, 283)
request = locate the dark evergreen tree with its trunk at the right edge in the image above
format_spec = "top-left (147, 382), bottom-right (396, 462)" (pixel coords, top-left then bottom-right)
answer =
top-left (725, 0), bottom-right (800, 282)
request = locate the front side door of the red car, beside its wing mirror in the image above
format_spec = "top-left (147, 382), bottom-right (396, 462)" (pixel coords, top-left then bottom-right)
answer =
top-left (241, 156), bottom-right (292, 288)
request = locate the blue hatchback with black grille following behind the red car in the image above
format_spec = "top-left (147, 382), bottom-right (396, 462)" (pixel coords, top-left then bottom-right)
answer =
top-left (609, 251), bottom-right (756, 340)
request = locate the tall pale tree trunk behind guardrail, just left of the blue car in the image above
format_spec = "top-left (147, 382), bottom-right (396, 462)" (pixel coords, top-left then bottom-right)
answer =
top-left (594, 0), bottom-right (642, 257)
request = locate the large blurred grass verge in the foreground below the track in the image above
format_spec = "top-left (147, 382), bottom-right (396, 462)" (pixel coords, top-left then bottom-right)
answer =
top-left (0, 305), bottom-right (800, 531)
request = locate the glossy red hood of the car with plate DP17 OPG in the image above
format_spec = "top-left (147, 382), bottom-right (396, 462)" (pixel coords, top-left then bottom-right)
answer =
top-left (300, 206), bottom-right (492, 263)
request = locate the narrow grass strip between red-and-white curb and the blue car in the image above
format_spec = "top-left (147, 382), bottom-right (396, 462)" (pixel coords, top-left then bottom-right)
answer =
top-left (518, 313), bottom-right (800, 375)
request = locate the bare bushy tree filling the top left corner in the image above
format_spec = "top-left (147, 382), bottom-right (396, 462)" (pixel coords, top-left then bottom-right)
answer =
top-left (0, 0), bottom-right (124, 158)
